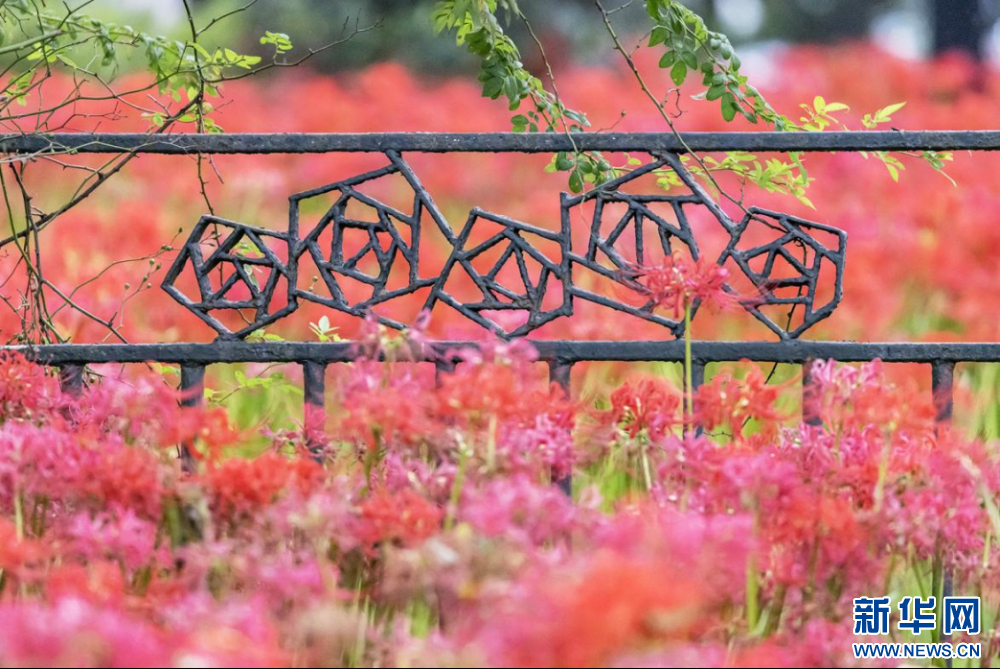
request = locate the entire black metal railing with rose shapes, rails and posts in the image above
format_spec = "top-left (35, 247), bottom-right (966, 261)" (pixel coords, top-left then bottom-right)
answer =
top-left (0, 131), bottom-right (1000, 434)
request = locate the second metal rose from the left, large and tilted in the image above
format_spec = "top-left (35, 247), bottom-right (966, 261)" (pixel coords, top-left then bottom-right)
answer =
top-left (290, 152), bottom-right (454, 328)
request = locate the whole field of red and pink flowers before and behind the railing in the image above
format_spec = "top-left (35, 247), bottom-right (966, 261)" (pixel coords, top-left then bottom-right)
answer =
top-left (0, 45), bottom-right (1000, 667)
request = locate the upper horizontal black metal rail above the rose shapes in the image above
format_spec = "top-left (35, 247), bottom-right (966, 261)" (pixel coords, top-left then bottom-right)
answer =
top-left (0, 130), bottom-right (1000, 154)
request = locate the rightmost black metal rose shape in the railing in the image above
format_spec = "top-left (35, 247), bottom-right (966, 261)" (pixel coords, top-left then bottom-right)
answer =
top-left (718, 207), bottom-right (847, 339)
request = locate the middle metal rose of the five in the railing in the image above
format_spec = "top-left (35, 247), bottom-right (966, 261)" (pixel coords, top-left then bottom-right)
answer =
top-left (426, 208), bottom-right (572, 337)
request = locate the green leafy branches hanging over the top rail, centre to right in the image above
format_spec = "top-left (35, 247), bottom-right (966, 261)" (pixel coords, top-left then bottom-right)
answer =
top-left (433, 0), bottom-right (951, 207)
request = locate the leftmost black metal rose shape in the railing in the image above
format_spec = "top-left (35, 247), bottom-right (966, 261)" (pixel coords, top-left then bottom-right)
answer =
top-left (162, 216), bottom-right (297, 339)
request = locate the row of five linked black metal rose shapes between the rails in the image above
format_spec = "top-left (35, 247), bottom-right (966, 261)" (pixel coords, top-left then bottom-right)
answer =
top-left (163, 151), bottom-right (847, 339)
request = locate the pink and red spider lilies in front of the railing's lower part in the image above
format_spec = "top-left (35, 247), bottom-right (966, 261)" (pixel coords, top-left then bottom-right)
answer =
top-left (0, 322), bottom-right (1000, 666)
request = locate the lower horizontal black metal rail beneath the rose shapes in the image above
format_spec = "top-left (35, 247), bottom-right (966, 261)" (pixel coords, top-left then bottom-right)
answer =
top-left (7, 340), bottom-right (1000, 365)
